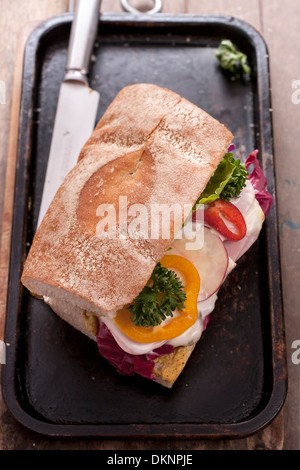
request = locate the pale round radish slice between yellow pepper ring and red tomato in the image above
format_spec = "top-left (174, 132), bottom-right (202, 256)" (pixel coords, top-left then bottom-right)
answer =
top-left (166, 226), bottom-right (228, 302)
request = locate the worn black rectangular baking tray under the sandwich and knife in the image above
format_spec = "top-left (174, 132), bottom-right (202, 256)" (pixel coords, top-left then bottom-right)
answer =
top-left (2, 13), bottom-right (287, 438)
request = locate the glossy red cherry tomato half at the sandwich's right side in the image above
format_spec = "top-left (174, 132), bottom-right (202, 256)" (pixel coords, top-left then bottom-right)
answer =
top-left (204, 199), bottom-right (247, 240)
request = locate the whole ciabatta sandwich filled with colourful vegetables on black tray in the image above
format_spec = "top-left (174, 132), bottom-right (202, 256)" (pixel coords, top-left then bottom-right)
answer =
top-left (21, 83), bottom-right (272, 388)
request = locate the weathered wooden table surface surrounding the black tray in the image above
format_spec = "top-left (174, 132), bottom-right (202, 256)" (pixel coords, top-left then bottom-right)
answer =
top-left (0, 0), bottom-right (300, 450)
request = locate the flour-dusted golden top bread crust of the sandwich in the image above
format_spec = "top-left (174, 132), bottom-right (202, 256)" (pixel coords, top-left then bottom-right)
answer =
top-left (22, 84), bottom-right (233, 314)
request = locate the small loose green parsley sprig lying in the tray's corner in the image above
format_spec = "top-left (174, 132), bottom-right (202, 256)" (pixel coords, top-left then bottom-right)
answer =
top-left (215, 39), bottom-right (251, 76)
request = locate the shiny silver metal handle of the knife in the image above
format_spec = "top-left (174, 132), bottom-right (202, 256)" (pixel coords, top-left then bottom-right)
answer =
top-left (65, 0), bottom-right (101, 84)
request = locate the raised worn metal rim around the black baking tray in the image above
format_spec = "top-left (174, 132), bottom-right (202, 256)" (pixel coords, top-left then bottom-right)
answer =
top-left (1, 13), bottom-right (287, 439)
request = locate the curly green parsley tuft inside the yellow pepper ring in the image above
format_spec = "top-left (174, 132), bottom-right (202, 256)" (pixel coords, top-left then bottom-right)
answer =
top-left (129, 263), bottom-right (186, 327)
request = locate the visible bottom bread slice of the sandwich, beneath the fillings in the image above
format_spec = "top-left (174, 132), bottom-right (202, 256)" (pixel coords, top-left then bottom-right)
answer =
top-left (42, 294), bottom-right (195, 388)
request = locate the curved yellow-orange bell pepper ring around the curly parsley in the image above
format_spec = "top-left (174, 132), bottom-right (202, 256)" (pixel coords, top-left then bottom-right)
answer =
top-left (114, 255), bottom-right (200, 343)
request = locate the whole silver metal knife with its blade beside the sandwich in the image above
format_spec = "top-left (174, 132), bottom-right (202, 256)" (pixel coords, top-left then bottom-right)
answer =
top-left (37, 0), bottom-right (101, 226)
